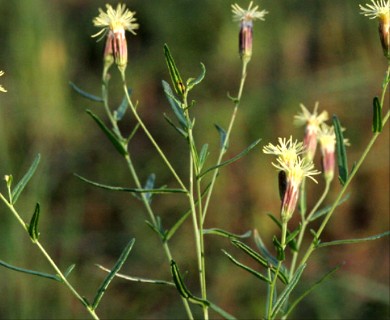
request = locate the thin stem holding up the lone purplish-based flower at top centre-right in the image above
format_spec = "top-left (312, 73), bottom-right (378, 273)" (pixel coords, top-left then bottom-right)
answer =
top-left (202, 61), bottom-right (248, 222)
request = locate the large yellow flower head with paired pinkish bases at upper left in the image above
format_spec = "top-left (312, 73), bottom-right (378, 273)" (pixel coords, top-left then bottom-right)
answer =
top-left (92, 3), bottom-right (139, 72)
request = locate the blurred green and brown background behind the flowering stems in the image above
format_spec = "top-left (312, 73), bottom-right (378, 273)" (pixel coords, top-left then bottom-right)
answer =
top-left (0, 0), bottom-right (390, 319)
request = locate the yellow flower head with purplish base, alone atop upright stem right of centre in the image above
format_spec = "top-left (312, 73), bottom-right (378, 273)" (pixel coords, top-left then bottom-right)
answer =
top-left (232, 1), bottom-right (268, 62)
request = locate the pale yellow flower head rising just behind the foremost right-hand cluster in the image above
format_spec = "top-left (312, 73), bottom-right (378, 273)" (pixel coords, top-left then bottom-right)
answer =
top-left (294, 102), bottom-right (328, 160)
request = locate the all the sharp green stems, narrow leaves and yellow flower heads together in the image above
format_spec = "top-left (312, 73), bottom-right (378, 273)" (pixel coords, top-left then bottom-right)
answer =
top-left (0, 0), bottom-right (390, 319)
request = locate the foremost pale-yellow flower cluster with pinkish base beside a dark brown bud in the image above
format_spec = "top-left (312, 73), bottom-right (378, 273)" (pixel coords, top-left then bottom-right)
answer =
top-left (263, 137), bottom-right (320, 221)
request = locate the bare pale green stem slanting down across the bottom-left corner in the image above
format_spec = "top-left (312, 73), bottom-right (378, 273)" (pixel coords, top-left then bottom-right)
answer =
top-left (0, 193), bottom-right (99, 319)
